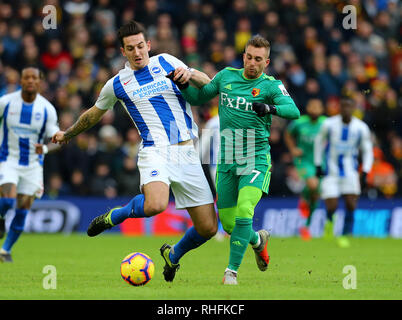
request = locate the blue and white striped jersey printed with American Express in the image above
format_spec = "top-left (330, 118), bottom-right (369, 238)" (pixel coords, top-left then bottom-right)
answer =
top-left (95, 53), bottom-right (198, 147)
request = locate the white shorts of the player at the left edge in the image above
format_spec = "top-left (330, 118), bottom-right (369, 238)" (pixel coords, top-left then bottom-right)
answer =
top-left (0, 160), bottom-right (43, 198)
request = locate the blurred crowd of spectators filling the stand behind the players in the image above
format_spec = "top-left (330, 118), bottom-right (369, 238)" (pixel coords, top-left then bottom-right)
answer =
top-left (0, 0), bottom-right (402, 198)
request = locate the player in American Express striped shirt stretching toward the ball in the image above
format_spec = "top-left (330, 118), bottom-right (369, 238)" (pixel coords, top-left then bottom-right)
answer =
top-left (53, 21), bottom-right (217, 281)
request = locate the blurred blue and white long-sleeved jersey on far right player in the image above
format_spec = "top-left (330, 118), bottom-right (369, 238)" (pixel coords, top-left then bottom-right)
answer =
top-left (314, 115), bottom-right (373, 177)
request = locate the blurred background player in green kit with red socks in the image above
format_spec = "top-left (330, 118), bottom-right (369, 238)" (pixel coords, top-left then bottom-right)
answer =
top-left (284, 99), bottom-right (326, 240)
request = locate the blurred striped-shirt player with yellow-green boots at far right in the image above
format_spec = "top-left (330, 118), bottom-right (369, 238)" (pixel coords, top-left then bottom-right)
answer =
top-left (314, 95), bottom-right (373, 247)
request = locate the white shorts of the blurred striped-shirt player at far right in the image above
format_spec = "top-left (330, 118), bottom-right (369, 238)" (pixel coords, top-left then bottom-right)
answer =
top-left (321, 174), bottom-right (360, 199)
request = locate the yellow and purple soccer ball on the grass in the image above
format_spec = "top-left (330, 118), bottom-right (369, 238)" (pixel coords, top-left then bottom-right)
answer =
top-left (120, 252), bottom-right (155, 287)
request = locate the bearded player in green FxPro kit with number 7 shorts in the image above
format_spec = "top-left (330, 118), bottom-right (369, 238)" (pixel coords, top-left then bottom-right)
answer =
top-left (174, 35), bottom-right (300, 285)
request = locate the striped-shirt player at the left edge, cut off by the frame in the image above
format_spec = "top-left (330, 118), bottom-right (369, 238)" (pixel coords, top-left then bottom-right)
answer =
top-left (0, 67), bottom-right (59, 262)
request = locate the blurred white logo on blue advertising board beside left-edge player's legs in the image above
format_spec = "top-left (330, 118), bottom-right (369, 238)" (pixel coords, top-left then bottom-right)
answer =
top-left (6, 200), bottom-right (81, 233)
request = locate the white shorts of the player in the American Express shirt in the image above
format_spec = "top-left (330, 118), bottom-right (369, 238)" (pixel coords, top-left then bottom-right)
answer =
top-left (138, 144), bottom-right (214, 209)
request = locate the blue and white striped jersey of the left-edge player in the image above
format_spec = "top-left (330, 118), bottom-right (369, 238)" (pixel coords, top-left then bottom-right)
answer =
top-left (0, 90), bottom-right (59, 167)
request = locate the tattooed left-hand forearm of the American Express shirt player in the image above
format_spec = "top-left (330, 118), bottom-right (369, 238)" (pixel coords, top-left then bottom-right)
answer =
top-left (52, 106), bottom-right (107, 144)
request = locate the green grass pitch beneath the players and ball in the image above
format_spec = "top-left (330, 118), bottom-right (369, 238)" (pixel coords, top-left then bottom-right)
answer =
top-left (0, 234), bottom-right (402, 300)
